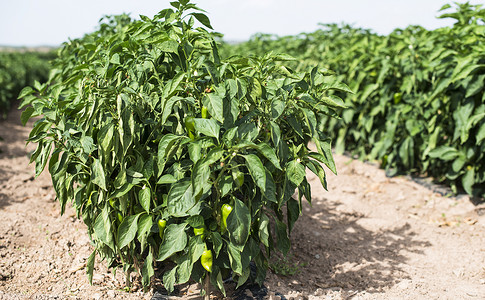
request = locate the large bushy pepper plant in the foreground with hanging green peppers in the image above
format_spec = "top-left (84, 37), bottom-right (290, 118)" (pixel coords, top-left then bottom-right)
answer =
top-left (21, 0), bottom-right (350, 292)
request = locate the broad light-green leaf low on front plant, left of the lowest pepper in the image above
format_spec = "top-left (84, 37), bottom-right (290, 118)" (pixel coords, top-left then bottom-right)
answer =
top-left (157, 223), bottom-right (187, 261)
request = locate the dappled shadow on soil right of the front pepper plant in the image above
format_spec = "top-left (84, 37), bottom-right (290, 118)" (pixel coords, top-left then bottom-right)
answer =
top-left (281, 200), bottom-right (431, 293)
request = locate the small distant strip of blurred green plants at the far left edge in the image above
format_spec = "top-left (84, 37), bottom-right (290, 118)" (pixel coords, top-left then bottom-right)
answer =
top-left (0, 51), bottom-right (54, 118)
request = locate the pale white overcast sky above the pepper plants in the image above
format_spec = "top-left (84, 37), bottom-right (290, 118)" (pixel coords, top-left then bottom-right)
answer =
top-left (0, 0), bottom-right (484, 47)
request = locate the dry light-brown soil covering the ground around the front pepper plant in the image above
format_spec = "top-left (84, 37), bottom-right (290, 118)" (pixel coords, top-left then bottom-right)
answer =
top-left (0, 105), bottom-right (485, 299)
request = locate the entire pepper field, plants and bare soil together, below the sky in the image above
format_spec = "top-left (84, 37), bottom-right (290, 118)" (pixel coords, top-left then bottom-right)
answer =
top-left (0, 0), bottom-right (485, 299)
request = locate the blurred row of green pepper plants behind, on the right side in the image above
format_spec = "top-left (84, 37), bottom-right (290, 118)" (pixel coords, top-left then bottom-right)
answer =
top-left (224, 3), bottom-right (485, 198)
